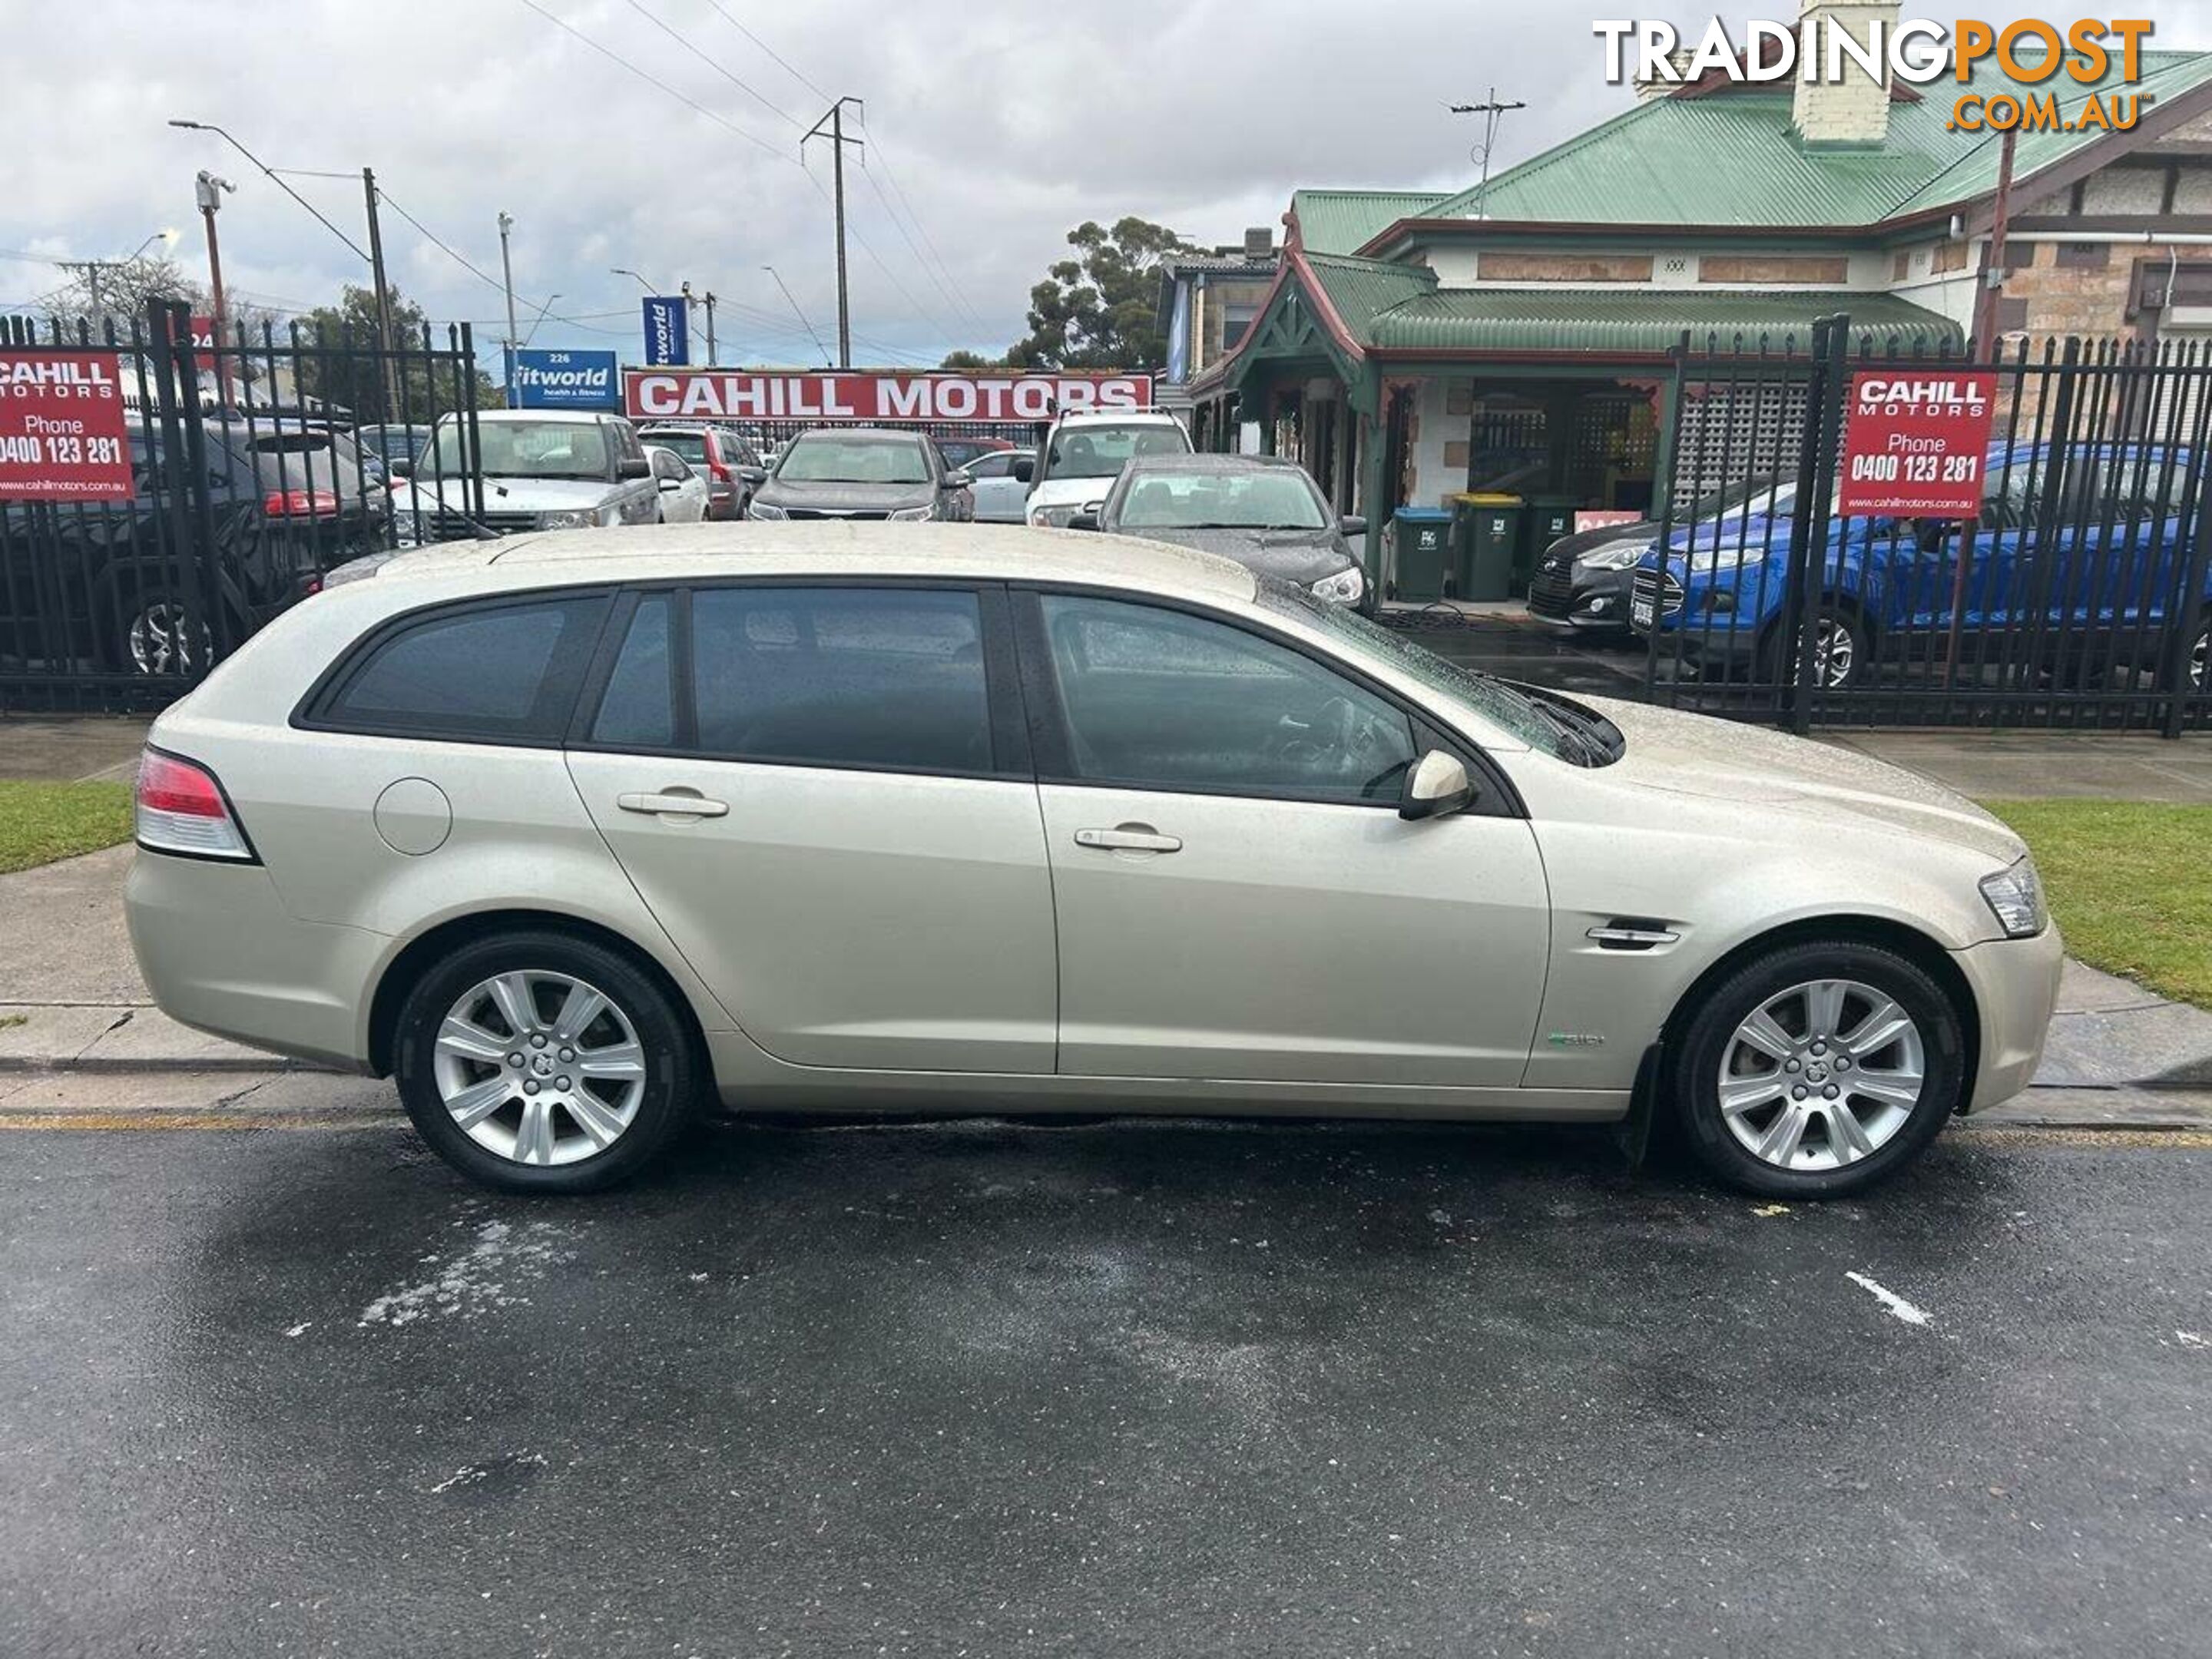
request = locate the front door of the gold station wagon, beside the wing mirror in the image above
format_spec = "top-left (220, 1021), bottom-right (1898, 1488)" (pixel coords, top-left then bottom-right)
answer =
top-left (1015, 593), bottom-right (1551, 1088)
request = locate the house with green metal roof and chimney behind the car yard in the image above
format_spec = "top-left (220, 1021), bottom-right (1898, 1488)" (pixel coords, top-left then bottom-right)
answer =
top-left (1184, 0), bottom-right (2212, 592)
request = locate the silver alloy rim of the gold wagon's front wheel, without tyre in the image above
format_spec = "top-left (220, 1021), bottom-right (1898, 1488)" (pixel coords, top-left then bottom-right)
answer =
top-left (1719, 980), bottom-right (1926, 1172)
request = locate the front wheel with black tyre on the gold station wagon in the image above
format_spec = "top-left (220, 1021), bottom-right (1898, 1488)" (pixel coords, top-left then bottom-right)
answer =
top-left (1670, 942), bottom-right (1966, 1199)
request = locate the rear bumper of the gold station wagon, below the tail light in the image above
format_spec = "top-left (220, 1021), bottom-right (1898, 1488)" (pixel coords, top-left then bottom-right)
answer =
top-left (124, 849), bottom-right (389, 1068)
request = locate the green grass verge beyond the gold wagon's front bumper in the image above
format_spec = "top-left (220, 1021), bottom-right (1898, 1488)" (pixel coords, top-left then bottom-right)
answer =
top-left (1986, 801), bottom-right (2212, 1008)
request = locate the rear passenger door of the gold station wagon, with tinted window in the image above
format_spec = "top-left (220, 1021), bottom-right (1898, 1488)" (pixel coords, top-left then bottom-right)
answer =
top-left (568, 584), bottom-right (1058, 1073)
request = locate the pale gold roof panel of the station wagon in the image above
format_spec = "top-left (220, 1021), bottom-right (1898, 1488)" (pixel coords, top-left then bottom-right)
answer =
top-left (378, 520), bottom-right (1254, 599)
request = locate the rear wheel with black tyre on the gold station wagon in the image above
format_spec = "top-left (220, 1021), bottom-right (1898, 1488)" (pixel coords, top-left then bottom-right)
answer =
top-left (392, 933), bottom-right (706, 1192)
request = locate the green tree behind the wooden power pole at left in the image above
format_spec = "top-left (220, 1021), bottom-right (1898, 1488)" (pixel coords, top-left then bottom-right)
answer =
top-left (290, 283), bottom-right (507, 422)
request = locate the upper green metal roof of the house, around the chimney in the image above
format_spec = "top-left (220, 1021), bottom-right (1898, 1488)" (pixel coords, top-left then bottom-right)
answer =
top-left (1406, 51), bottom-right (2212, 234)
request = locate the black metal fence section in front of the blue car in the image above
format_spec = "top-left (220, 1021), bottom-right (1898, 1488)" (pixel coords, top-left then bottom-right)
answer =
top-left (1631, 316), bottom-right (2212, 737)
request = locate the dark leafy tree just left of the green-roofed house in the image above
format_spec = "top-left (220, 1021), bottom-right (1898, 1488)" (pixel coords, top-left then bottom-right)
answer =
top-left (1006, 217), bottom-right (1197, 372)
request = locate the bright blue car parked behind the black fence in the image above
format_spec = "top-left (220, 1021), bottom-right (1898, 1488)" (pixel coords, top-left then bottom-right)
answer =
top-left (1631, 442), bottom-right (2212, 690)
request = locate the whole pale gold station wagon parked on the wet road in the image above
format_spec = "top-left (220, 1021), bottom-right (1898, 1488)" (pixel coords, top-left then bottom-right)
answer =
top-left (128, 525), bottom-right (2059, 1197)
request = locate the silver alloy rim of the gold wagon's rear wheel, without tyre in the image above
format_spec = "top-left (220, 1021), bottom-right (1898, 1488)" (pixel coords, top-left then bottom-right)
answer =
top-left (432, 969), bottom-right (646, 1168)
